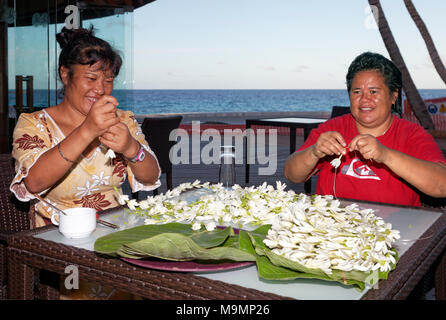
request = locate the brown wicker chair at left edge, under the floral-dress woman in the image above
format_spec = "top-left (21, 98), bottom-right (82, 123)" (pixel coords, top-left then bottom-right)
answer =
top-left (0, 153), bottom-right (30, 299)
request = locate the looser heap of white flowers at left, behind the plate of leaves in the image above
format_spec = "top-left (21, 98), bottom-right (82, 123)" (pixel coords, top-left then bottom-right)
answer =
top-left (119, 180), bottom-right (299, 231)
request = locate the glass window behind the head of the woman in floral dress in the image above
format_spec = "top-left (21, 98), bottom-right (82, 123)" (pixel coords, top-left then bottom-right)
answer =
top-left (8, 0), bottom-right (133, 111)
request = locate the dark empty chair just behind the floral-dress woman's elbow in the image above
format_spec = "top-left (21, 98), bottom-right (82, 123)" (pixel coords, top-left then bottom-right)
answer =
top-left (132, 116), bottom-right (183, 199)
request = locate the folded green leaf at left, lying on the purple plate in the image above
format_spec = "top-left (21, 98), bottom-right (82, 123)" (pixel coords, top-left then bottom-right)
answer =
top-left (94, 223), bottom-right (251, 261)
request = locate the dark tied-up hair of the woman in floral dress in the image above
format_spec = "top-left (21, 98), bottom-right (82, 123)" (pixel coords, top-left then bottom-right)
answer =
top-left (56, 26), bottom-right (122, 79)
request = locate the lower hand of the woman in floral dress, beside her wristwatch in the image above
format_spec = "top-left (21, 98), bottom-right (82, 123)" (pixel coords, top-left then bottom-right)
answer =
top-left (99, 122), bottom-right (139, 158)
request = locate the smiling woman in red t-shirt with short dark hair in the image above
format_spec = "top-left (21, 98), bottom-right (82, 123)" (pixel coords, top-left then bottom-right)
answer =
top-left (284, 52), bottom-right (446, 206)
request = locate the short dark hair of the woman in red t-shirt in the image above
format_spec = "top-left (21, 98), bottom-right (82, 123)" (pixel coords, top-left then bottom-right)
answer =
top-left (346, 52), bottom-right (403, 116)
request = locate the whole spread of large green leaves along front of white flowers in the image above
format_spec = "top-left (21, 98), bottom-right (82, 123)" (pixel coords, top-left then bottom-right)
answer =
top-left (95, 223), bottom-right (398, 290)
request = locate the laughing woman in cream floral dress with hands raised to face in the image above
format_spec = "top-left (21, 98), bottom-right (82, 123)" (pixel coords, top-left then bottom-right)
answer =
top-left (11, 28), bottom-right (160, 226)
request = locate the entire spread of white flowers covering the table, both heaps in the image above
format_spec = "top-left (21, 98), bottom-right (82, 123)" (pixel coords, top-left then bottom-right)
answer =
top-left (119, 180), bottom-right (399, 274)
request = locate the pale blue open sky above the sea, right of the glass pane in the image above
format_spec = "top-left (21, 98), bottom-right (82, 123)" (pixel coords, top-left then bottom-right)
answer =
top-left (133, 0), bottom-right (446, 89)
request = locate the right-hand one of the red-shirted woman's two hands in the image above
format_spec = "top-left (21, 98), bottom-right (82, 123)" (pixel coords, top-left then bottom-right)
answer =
top-left (348, 134), bottom-right (388, 163)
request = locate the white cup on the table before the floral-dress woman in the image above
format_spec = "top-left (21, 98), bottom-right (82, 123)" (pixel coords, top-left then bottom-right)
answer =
top-left (51, 208), bottom-right (96, 239)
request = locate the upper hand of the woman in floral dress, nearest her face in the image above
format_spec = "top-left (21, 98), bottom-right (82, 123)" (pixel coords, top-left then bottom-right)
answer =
top-left (81, 95), bottom-right (119, 139)
